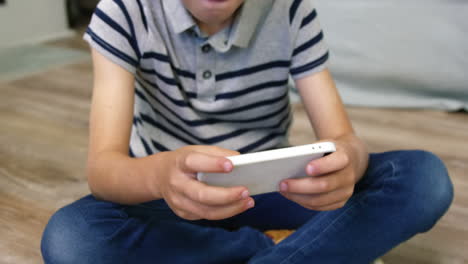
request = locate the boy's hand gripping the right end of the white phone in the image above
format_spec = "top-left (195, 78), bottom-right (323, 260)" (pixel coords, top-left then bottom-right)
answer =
top-left (280, 142), bottom-right (361, 211)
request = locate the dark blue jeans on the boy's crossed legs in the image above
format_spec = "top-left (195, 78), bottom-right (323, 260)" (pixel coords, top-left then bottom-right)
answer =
top-left (41, 151), bottom-right (453, 264)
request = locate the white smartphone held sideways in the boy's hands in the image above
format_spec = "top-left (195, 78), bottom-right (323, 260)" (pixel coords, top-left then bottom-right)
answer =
top-left (197, 142), bottom-right (336, 195)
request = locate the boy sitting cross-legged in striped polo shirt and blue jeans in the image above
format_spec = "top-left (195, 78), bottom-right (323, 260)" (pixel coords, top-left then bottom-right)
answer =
top-left (42, 0), bottom-right (452, 263)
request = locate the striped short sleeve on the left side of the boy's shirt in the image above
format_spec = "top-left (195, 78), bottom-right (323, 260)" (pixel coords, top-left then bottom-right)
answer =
top-left (83, 0), bottom-right (146, 74)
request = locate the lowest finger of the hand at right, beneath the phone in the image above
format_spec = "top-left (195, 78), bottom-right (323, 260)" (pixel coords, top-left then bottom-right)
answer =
top-left (282, 188), bottom-right (353, 208)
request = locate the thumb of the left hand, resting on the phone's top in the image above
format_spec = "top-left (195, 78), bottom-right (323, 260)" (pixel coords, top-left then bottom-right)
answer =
top-left (177, 151), bottom-right (233, 173)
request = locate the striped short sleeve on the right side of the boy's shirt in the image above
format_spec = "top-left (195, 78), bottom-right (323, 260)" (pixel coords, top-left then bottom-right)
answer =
top-left (289, 0), bottom-right (329, 80)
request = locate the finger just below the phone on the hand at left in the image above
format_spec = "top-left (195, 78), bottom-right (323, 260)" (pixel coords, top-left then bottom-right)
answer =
top-left (180, 179), bottom-right (250, 205)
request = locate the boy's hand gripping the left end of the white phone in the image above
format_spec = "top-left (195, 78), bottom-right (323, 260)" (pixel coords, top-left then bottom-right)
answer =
top-left (153, 146), bottom-right (254, 220)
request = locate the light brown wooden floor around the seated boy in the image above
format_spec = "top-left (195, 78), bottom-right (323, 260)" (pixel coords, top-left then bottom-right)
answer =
top-left (0, 33), bottom-right (468, 264)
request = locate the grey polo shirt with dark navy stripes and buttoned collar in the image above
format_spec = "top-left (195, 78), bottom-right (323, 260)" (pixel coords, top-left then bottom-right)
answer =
top-left (84, 0), bottom-right (328, 157)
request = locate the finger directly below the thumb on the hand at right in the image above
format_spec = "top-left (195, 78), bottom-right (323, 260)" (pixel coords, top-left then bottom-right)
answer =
top-left (280, 172), bottom-right (354, 194)
